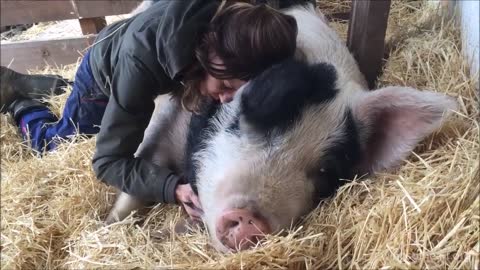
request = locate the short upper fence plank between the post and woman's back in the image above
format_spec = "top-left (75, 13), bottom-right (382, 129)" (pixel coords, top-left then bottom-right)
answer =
top-left (75, 0), bottom-right (142, 18)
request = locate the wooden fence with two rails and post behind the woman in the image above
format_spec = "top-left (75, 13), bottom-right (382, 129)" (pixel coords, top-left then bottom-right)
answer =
top-left (0, 0), bottom-right (141, 72)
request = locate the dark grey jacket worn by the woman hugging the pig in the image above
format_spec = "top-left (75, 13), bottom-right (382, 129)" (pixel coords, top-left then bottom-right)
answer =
top-left (90, 0), bottom-right (220, 203)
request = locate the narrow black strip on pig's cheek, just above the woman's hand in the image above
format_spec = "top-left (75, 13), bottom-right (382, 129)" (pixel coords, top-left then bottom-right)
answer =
top-left (185, 100), bottom-right (221, 195)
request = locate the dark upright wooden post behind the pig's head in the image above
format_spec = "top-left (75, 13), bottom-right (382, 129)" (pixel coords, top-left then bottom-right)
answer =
top-left (347, 0), bottom-right (391, 89)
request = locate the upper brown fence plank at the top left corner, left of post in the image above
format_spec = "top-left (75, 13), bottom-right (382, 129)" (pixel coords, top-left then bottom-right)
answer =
top-left (0, 0), bottom-right (77, 26)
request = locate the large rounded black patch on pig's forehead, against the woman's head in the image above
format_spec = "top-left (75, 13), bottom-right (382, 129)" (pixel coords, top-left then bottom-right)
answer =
top-left (240, 59), bottom-right (337, 133)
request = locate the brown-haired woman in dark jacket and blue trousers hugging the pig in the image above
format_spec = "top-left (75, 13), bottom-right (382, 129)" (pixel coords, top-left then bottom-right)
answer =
top-left (0, 0), bottom-right (304, 218)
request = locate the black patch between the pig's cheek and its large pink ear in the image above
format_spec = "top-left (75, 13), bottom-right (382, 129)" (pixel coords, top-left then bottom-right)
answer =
top-left (307, 110), bottom-right (361, 204)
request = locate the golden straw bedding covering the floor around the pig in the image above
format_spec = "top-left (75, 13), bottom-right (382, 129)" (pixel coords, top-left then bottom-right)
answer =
top-left (0, 0), bottom-right (480, 269)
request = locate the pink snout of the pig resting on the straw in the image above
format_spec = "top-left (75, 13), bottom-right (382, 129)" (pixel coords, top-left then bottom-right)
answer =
top-left (216, 209), bottom-right (271, 250)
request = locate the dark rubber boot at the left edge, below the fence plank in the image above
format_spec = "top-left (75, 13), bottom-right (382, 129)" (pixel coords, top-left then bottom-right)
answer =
top-left (0, 66), bottom-right (69, 112)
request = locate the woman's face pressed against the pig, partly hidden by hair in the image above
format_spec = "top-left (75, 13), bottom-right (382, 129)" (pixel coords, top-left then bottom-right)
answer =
top-left (200, 56), bottom-right (246, 103)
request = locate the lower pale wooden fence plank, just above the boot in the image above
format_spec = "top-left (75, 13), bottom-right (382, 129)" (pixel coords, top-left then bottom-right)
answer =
top-left (0, 35), bottom-right (95, 72)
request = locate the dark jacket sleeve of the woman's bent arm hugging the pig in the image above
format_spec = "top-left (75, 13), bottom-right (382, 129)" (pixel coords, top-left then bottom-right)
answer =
top-left (93, 55), bottom-right (179, 203)
